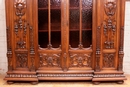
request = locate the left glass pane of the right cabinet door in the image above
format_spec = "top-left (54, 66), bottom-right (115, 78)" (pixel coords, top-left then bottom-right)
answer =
top-left (69, 0), bottom-right (80, 48)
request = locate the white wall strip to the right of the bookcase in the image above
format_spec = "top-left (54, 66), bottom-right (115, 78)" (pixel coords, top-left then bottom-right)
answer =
top-left (124, 1), bottom-right (130, 74)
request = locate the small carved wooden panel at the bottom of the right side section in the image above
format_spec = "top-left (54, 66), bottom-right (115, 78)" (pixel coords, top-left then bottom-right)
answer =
top-left (103, 53), bottom-right (115, 68)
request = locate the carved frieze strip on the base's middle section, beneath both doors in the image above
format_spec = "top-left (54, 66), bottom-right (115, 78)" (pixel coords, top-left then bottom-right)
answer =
top-left (37, 73), bottom-right (93, 77)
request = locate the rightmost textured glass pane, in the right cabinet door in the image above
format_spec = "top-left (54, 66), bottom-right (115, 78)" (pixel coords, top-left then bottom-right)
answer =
top-left (82, 0), bottom-right (92, 48)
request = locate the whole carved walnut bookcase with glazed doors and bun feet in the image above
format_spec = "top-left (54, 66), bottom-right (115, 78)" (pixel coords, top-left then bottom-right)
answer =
top-left (5, 0), bottom-right (126, 84)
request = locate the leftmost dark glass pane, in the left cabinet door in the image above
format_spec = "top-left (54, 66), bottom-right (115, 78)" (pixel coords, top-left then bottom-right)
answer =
top-left (38, 0), bottom-right (48, 48)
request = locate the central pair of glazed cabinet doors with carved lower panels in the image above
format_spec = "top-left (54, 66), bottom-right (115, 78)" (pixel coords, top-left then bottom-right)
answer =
top-left (35, 0), bottom-right (96, 79)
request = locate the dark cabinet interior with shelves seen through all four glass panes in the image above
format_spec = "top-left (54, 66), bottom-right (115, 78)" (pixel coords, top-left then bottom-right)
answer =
top-left (38, 0), bottom-right (92, 48)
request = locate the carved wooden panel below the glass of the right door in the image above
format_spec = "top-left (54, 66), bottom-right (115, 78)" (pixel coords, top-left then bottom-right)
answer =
top-left (70, 53), bottom-right (92, 68)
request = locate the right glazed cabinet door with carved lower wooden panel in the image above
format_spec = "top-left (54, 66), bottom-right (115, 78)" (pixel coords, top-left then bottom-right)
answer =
top-left (66, 0), bottom-right (95, 73)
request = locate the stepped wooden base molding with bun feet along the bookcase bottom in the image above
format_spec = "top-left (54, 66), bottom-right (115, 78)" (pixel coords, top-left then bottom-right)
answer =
top-left (4, 72), bottom-right (127, 85)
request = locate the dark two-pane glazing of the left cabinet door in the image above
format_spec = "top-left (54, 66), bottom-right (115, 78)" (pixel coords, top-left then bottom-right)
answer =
top-left (38, 0), bottom-right (61, 48)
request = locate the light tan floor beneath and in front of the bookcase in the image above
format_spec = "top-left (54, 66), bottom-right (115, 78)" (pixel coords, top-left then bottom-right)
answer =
top-left (0, 74), bottom-right (130, 87)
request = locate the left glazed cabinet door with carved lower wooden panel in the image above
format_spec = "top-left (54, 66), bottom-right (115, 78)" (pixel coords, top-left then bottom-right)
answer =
top-left (37, 0), bottom-right (64, 73)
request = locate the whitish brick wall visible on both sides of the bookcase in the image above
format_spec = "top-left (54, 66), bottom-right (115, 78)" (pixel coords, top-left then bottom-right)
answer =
top-left (0, 0), bottom-right (130, 74)
